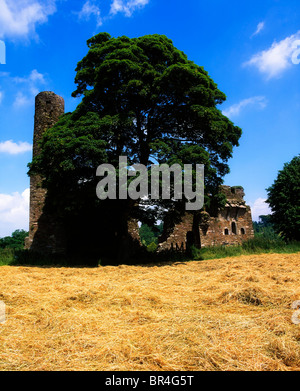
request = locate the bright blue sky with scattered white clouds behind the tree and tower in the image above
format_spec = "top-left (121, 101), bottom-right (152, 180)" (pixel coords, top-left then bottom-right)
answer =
top-left (0, 0), bottom-right (300, 237)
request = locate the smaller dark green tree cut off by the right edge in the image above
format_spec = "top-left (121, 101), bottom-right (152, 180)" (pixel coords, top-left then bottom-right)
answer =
top-left (267, 155), bottom-right (300, 240)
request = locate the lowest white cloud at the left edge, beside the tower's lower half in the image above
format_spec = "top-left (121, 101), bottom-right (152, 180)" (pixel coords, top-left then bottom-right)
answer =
top-left (0, 189), bottom-right (29, 237)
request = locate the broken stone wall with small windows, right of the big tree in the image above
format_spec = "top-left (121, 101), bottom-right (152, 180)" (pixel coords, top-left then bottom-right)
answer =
top-left (159, 186), bottom-right (254, 250)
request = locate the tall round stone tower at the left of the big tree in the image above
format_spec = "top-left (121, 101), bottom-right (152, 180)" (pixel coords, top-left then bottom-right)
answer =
top-left (25, 91), bottom-right (65, 253)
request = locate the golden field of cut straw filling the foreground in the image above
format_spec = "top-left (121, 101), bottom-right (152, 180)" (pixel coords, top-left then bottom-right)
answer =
top-left (0, 253), bottom-right (300, 371)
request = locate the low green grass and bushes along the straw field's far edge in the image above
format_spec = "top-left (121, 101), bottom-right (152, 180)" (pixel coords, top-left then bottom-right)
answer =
top-left (0, 215), bottom-right (300, 267)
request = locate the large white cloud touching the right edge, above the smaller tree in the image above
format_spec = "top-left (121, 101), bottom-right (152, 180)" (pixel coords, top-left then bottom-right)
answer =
top-left (243, 30), bottom-right (300, 79)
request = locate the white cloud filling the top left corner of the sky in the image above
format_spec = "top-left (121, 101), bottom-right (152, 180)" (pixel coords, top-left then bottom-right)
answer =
top-left (0, 0), bottom-right (56, 38)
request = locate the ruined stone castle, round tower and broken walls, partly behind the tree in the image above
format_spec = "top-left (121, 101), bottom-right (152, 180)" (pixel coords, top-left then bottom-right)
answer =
top-left (25, 91), bottom-right (254, 254)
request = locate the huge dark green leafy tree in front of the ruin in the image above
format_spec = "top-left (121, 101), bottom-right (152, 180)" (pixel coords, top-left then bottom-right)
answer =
top-left (30, 33), bottom-right (241, 260)
